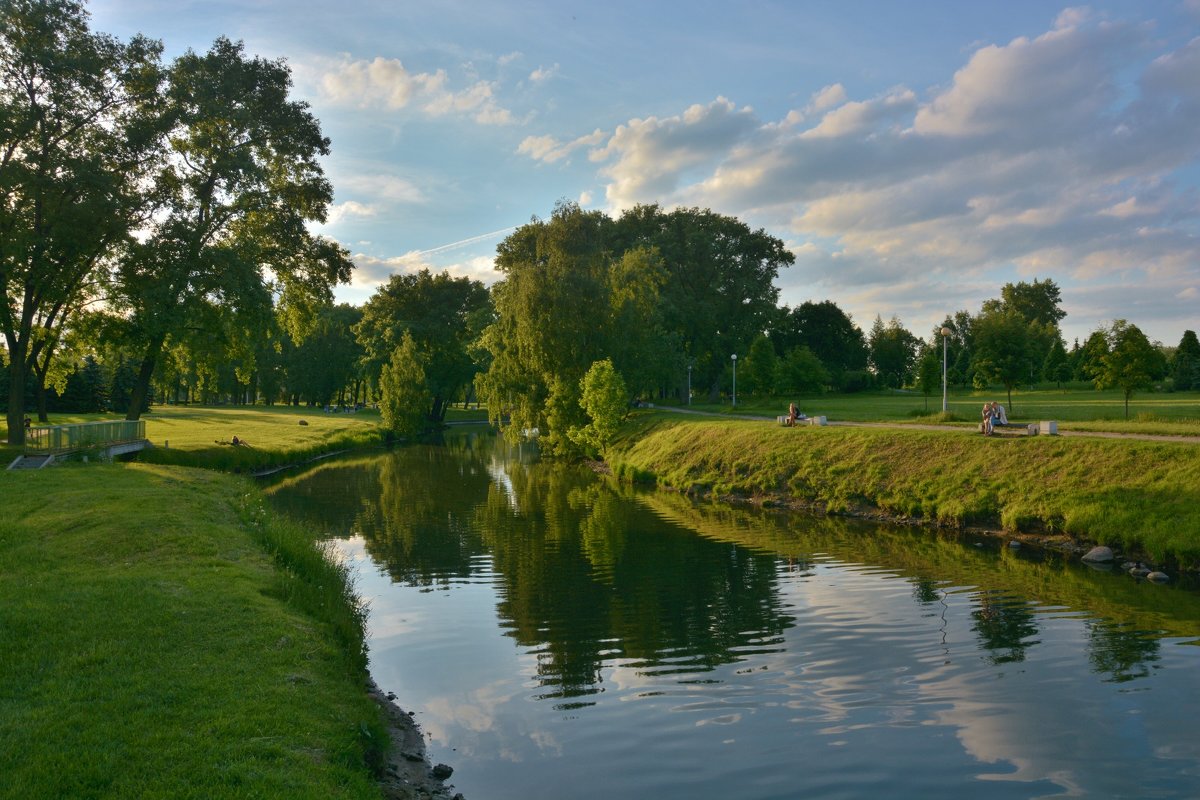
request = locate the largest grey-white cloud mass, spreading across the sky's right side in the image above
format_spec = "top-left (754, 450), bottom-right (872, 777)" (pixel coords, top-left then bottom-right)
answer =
top-left (521, 8), bottom-right (1200, 340)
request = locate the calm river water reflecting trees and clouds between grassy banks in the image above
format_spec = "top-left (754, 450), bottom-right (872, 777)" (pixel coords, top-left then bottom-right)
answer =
top-left (262, 429), bottom-right (1200, 800)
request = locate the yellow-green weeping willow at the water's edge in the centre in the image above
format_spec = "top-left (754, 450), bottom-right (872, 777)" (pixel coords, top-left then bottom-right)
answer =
top-left (476, 203), bottom-right (665, 455)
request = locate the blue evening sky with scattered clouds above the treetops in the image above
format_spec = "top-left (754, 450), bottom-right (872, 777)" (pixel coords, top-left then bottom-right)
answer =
top-left (88, 0), bottom-right (1200, 345)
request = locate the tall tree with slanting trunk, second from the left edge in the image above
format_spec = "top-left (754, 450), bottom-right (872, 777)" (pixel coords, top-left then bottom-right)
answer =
top-left (118, 38), bottom-right (352, 419)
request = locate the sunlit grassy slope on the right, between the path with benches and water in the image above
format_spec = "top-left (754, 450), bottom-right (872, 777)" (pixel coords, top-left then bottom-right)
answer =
top-left (608, 414), bottom-right (1200, 567)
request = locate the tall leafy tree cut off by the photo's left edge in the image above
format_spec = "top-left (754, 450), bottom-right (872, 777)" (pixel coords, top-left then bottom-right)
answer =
top-left (0, 0), bottom-right (161, 444)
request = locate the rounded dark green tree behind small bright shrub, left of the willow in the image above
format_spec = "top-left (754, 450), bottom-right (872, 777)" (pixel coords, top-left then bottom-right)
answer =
top-left (354, 270), bottom-right (492, 422)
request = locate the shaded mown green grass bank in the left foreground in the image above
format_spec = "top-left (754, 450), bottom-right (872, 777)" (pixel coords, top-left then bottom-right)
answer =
top-left (0, 464), bottom-right (385, 799)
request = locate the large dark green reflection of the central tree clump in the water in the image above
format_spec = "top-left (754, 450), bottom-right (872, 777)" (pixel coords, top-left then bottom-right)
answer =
top-left (478, 464), bottom-right (791, 698)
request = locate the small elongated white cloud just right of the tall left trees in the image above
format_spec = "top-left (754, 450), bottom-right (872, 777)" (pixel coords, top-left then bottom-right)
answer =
top-left (319, 56), bottom-right (515, 125)
